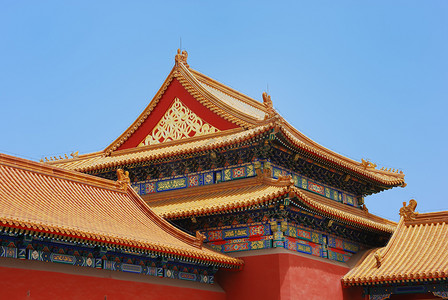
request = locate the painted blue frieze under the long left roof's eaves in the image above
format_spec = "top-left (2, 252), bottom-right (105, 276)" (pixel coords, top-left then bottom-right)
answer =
top-left (0, 235), bottom-right (217, 284)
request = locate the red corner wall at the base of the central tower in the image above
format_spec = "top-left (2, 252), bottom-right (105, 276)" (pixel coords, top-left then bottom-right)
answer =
top-left (216, 253), bottom-right (364, 300)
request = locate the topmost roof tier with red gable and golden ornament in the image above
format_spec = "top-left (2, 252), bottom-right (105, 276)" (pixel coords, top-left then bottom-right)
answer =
top-left (49, 51), bottom-right (405, 189)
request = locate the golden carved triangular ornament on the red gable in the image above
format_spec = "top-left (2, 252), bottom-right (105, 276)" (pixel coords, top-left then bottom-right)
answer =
top-left (138, 98), bottom-right (219, 147)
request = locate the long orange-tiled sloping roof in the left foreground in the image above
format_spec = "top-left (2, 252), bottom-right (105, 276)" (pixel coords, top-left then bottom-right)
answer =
top-left (0, 154), bottom-right (243, 267)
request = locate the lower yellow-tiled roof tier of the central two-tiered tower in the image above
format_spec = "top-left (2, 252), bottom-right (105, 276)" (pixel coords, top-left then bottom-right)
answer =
top-left (143, 175), bottom-right (396, 233)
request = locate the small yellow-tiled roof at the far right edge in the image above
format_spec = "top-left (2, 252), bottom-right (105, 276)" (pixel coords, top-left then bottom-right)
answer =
top-left (342, 200), bottom-right (448, 285)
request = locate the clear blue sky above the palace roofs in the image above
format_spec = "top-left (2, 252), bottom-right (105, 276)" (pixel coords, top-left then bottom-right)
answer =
top-left (0, 0), bottom-right (448, 220)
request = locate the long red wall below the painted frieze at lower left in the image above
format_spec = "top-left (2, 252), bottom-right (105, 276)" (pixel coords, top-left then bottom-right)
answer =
top-left (0, 267), bottom-right (225, 300)
